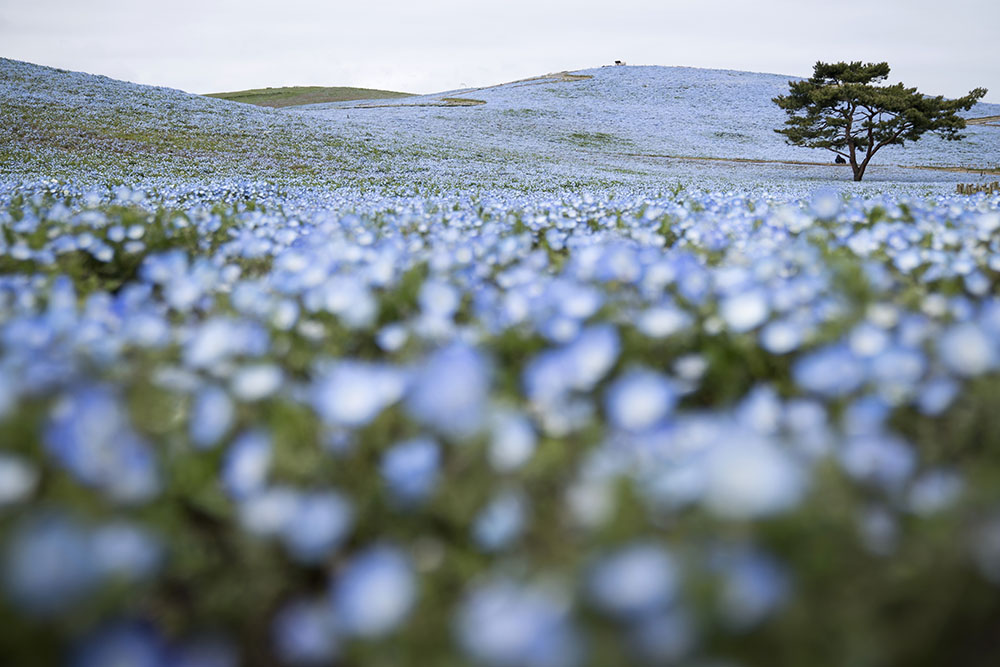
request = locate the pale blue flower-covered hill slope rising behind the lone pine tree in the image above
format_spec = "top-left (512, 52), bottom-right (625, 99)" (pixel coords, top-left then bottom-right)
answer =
top-left (294, 67), bottom-right (1000, 178)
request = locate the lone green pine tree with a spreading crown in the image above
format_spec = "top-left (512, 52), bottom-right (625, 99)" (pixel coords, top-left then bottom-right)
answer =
top-left (772, 62), bottom-right (986, 181)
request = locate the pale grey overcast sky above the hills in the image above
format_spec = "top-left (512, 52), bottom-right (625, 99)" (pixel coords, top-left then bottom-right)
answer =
top-left (0, 0), bottom-right (1000, 102)
